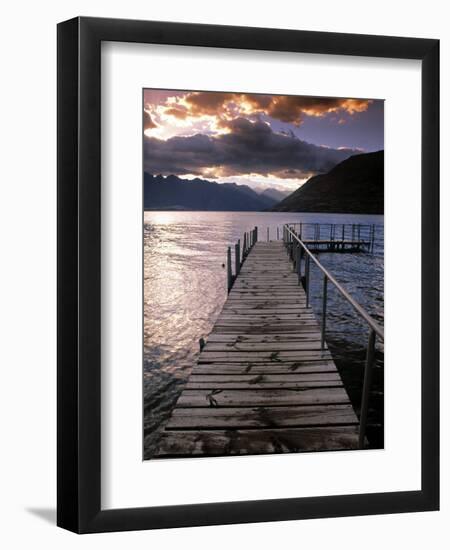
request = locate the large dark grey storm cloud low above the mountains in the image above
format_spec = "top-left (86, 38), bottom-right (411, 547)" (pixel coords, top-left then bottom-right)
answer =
top-left (144, 118), bottom-right (357, 178)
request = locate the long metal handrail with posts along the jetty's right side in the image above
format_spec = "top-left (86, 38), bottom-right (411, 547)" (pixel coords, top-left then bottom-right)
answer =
top-left (283, 224), bottom-right (384, 448)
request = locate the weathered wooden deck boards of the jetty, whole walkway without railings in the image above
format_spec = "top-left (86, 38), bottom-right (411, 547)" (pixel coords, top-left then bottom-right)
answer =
top-left (155, 241), bottom-right (358, 458)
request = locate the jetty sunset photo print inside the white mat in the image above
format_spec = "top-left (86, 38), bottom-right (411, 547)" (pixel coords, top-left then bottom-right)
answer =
top-left (143, 89), bottom-right (384, 460)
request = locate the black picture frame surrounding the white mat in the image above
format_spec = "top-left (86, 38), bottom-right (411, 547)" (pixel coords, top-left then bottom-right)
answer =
top-left (57, 17), bottom-right (439, 533)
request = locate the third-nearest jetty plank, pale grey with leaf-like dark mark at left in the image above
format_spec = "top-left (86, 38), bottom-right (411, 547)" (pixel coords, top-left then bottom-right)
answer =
top-left (177, 388), bottom-right (348, 407)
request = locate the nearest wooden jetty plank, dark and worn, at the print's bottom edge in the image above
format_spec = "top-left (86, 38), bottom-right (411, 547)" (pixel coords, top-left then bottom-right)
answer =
top-left (155, 426), bottom-right (358, 458)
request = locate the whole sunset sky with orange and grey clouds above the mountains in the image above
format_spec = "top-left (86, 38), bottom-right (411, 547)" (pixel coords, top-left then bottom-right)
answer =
top-left (144, 90), bottom-right (384, 191)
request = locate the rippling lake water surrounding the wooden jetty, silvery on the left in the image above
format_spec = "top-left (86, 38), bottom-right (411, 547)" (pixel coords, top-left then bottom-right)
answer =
top-left (143, 212), bottom-right (384, 459)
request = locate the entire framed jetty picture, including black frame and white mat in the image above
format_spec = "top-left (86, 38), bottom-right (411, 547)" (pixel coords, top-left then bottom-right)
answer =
top-left (58, 17), bottom-right (439, 533)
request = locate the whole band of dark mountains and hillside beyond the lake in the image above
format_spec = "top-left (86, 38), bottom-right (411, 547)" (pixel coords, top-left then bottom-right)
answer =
top-left (144, 151), bottom-right (384, 214)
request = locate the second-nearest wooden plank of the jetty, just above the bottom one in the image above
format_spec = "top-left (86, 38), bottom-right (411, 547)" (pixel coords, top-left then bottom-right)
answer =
top-left (166, 405), bottom-right (358, 429)
